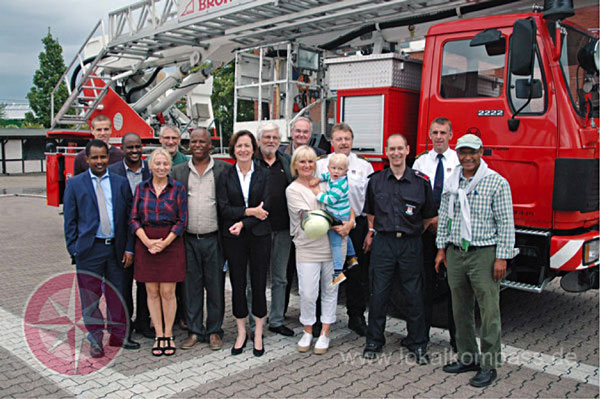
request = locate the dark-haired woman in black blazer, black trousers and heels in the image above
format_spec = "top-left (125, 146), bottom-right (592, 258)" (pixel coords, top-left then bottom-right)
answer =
top-left (217, 130), bottom-right (271, 356)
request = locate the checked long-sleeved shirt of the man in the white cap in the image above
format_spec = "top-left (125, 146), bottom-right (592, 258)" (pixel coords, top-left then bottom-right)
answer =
top-left (436, 171), bottom-right (518, 259)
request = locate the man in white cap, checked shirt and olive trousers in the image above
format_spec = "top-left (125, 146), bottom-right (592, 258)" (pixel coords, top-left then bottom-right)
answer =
top-left (435, 134), bottom-right (518, 387)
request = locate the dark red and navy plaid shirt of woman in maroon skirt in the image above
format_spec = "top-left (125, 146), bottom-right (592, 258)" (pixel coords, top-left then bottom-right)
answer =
top-left (130, 178), bottom-right (188, 236)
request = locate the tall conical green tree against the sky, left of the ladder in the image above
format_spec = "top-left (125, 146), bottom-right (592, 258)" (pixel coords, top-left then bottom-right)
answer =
top-left (25, 28), bottom-right (68, 128)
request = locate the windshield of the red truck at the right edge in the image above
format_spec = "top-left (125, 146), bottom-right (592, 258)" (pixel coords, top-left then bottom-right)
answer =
top-left (551, 25), bottom-right (598, 117)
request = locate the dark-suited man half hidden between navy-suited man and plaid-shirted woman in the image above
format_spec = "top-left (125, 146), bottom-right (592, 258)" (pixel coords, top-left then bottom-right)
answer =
top-left (108, 132), bottom-right (154, 349)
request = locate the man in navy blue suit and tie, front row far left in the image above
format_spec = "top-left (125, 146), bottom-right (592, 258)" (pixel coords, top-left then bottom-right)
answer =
top-left (64, 140), bottom-right (134, 358)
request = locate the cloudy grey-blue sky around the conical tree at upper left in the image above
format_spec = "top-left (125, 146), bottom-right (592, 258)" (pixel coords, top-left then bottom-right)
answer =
top-left (0, 0), bottom-right (124, 102)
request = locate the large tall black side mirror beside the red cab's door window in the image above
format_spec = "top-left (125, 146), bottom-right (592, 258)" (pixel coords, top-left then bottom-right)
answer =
top-left (510, 19), bottom-right (535, 76)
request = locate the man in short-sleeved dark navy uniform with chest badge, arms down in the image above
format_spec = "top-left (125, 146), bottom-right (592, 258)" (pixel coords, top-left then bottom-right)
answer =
top-left (363, 134), bottom-right (437, 364)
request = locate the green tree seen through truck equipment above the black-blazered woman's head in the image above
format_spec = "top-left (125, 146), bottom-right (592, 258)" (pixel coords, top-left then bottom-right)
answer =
top-left (210, 61), bottom-right (254, 143)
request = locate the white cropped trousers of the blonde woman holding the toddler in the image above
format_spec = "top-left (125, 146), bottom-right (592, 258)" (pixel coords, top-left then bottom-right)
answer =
top-left (296, 261), bottom-right (339, 326)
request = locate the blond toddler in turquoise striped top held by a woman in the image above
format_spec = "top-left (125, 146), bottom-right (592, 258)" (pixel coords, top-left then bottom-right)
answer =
top-left (317, 154), bottom-right (358, 286)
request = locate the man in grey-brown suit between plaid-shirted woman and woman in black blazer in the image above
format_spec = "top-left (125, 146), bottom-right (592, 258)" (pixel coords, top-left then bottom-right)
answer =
top-left (171, 129), bottom-right (231, 350)
